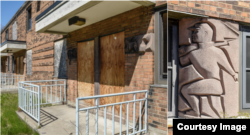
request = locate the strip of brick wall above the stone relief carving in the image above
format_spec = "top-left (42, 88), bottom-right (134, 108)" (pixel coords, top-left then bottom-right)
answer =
top-left (167, 0), bottom-right (250, 23)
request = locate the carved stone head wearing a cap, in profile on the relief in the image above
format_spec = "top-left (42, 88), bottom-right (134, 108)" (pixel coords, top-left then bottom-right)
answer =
top-left (190, 23), bottom-right (213, 43)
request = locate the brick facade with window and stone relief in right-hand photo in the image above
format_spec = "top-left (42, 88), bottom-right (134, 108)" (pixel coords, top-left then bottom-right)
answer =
top-left (167, 0), bottom-right (250, 134)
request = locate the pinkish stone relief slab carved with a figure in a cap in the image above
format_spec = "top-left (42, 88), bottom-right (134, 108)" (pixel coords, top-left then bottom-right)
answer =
top-left (178, 18), bottom-right (239, 118)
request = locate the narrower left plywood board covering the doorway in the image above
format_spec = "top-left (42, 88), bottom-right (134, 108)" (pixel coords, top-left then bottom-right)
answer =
top-left (77, 40), bottom-right (94, 105)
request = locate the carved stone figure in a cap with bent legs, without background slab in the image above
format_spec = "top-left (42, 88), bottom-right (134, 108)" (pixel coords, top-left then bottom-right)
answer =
top-left (179, 22), bottom-right (238, 117)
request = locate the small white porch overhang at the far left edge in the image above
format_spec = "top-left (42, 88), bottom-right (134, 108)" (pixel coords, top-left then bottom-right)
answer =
top-left (0, 40), bottom-right (26, 53)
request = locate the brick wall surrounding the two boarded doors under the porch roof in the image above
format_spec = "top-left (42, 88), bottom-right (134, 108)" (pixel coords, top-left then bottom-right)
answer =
top-left (67, 2), bottom-right (167, 134)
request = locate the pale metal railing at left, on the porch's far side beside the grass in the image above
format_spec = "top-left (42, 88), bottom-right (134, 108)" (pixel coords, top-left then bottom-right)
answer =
top-left (18, 79), bottom-right (66, 126)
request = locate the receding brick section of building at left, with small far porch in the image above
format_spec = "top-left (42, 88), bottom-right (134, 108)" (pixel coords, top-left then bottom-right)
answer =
top-left (0, 0), bottom-right (63, 80)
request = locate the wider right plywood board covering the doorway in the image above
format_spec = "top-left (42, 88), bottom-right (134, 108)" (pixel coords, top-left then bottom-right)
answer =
top-left (100, 32), bottom-right (125, 114)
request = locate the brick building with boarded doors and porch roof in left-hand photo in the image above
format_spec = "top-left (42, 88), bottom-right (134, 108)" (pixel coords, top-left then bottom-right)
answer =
top-left (0, 0), bottom-right (168, 135)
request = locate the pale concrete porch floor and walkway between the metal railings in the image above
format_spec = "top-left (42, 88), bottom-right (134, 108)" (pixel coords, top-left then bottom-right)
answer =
top-left (16, 105), bottom-right (137, 135)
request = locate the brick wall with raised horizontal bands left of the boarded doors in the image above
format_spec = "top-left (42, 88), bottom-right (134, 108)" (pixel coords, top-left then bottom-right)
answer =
top-left (26, 0), bottom-right (63, 80)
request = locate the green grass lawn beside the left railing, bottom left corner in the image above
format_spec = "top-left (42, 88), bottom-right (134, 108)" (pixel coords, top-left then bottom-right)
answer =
top-left (0, 93), bottom-right (39, 135)
